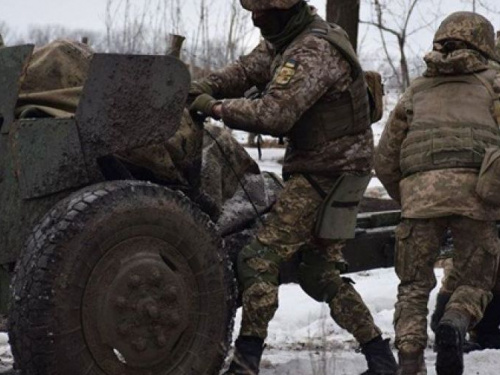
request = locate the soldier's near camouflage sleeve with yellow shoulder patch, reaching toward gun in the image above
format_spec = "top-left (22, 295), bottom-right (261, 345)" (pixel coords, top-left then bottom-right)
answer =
top-left (221, 35), bottom-right (352, 136)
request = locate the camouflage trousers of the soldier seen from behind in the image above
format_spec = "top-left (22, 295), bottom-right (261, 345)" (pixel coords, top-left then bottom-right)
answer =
top-left (394, 215), bottom-right (500, 352)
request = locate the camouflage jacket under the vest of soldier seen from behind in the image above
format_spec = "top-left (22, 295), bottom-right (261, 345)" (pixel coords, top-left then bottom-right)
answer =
top-left (375, 52), bottom-right (500, 220)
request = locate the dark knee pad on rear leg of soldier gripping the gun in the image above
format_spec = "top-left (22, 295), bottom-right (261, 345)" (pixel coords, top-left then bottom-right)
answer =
top-left (298, 251), bottom-right (347, 303)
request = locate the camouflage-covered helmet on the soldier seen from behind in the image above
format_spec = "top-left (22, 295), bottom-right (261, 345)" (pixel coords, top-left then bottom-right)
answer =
top-left (434, 12), bottom-right (498, 60)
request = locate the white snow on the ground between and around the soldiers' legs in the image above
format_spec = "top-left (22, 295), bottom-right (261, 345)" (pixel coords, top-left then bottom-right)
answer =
top-left (229, 268), bottom-right (500, 375)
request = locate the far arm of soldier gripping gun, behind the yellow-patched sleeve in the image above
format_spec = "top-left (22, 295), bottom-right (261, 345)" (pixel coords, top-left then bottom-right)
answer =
top-left (198, 41), bottom-right (273, 99)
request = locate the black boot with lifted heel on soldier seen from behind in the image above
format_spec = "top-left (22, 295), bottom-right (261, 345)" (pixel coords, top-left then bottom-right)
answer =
top-left (436, 310), bottom-right (470, 375)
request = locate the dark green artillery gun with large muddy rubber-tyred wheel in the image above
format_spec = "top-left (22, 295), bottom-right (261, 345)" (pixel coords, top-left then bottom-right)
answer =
top-left (0, 46), bottom-right (398, 375)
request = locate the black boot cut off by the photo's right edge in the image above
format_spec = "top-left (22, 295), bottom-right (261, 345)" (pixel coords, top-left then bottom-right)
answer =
top-left (474, 294), bottom-right (500, 349)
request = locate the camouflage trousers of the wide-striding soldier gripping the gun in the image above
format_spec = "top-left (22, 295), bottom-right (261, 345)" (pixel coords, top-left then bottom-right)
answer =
top-left (238, 175), bottom-right (381, 343)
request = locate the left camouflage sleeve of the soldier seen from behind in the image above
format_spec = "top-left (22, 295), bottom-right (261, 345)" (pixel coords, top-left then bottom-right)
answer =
top-left (375, 97), bottom-right (408, 203)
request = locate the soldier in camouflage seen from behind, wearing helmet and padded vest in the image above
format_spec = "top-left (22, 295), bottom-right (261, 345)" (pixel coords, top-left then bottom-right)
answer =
top-left (375, 12), bottom-right (500, 375)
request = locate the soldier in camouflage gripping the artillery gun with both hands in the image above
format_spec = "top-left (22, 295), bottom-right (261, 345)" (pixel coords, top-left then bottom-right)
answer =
top-left (191, 0), bottom-right (397, 375)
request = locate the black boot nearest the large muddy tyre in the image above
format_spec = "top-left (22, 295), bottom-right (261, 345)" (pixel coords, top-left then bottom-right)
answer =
top-left (224, 336), bottom-right (264, 375)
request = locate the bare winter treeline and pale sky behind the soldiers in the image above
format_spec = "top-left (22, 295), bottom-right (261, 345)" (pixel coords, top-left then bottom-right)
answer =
top-left (0, 0), bottom-right (500, 92)
